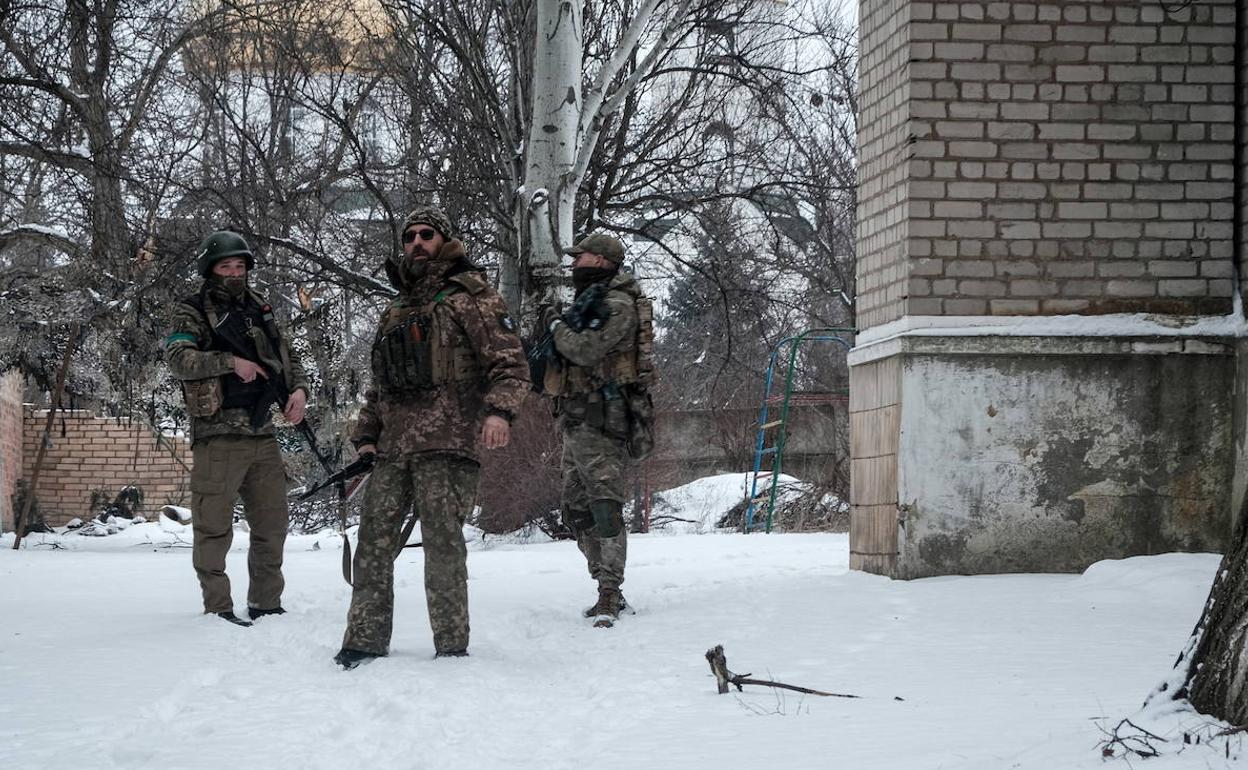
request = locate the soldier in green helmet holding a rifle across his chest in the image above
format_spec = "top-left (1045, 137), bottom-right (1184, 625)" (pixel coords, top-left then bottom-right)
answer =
top-left (165, 231), bottom-right (308, 625)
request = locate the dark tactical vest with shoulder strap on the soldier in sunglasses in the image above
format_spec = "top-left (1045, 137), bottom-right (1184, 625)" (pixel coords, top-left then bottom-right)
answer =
top-left (372, 273), bottom-right (487, 398)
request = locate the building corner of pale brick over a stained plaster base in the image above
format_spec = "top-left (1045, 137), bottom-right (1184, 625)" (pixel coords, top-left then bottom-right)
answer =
top-left (850, 0), bottom-right (1238, 577)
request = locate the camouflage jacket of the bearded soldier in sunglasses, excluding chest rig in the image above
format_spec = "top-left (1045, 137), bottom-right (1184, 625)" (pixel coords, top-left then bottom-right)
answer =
top-left (351, 240), bottom-right (529, 459)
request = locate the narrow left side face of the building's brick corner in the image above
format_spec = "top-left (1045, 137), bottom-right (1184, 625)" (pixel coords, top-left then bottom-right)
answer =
top-left (856, 0), bottom-right (910, 328)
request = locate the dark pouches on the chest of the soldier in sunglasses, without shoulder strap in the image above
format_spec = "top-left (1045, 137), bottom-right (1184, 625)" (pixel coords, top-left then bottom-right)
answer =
top-left (372, 305), bottom-right (483, 398)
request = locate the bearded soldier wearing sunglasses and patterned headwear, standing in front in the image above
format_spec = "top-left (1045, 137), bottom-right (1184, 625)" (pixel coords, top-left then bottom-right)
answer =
top-left (334, 206), bottom-right (529, 669)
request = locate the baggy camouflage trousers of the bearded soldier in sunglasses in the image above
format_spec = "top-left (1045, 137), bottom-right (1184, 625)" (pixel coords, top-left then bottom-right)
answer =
top-left (342, 454), bottom-right (480, 655)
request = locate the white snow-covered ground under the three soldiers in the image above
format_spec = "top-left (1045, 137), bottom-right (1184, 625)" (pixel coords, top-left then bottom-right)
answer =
top-left (0, 471), bottom-right (1243, 770)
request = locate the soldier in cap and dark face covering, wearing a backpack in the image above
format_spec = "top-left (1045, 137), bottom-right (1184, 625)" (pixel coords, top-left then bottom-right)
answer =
top-left (542, 233), bottom-right (653, 628)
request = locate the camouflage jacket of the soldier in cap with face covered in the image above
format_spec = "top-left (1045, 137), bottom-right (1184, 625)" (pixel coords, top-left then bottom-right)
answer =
top-left (554, 270), bottom-right (641, 401)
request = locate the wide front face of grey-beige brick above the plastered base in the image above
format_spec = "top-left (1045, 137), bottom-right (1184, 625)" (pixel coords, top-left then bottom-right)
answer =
top-left (888, 0), bottom-right (1236, 318)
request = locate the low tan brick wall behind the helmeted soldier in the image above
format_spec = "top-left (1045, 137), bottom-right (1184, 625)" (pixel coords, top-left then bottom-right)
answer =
top-left (22, 407), bottom-right (191, 524)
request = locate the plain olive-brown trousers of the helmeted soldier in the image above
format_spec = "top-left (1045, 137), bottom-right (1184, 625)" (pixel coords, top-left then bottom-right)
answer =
top-left (191, 436), bottom-right (290, 613)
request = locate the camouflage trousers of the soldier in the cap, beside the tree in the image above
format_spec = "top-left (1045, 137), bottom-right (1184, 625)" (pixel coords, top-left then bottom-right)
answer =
top-left (560, 421), bottom-right (628, 589)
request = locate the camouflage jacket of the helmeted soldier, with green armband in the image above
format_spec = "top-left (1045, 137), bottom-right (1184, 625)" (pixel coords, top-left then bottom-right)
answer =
top-left (165, 286), bottom-right (310, 443)
